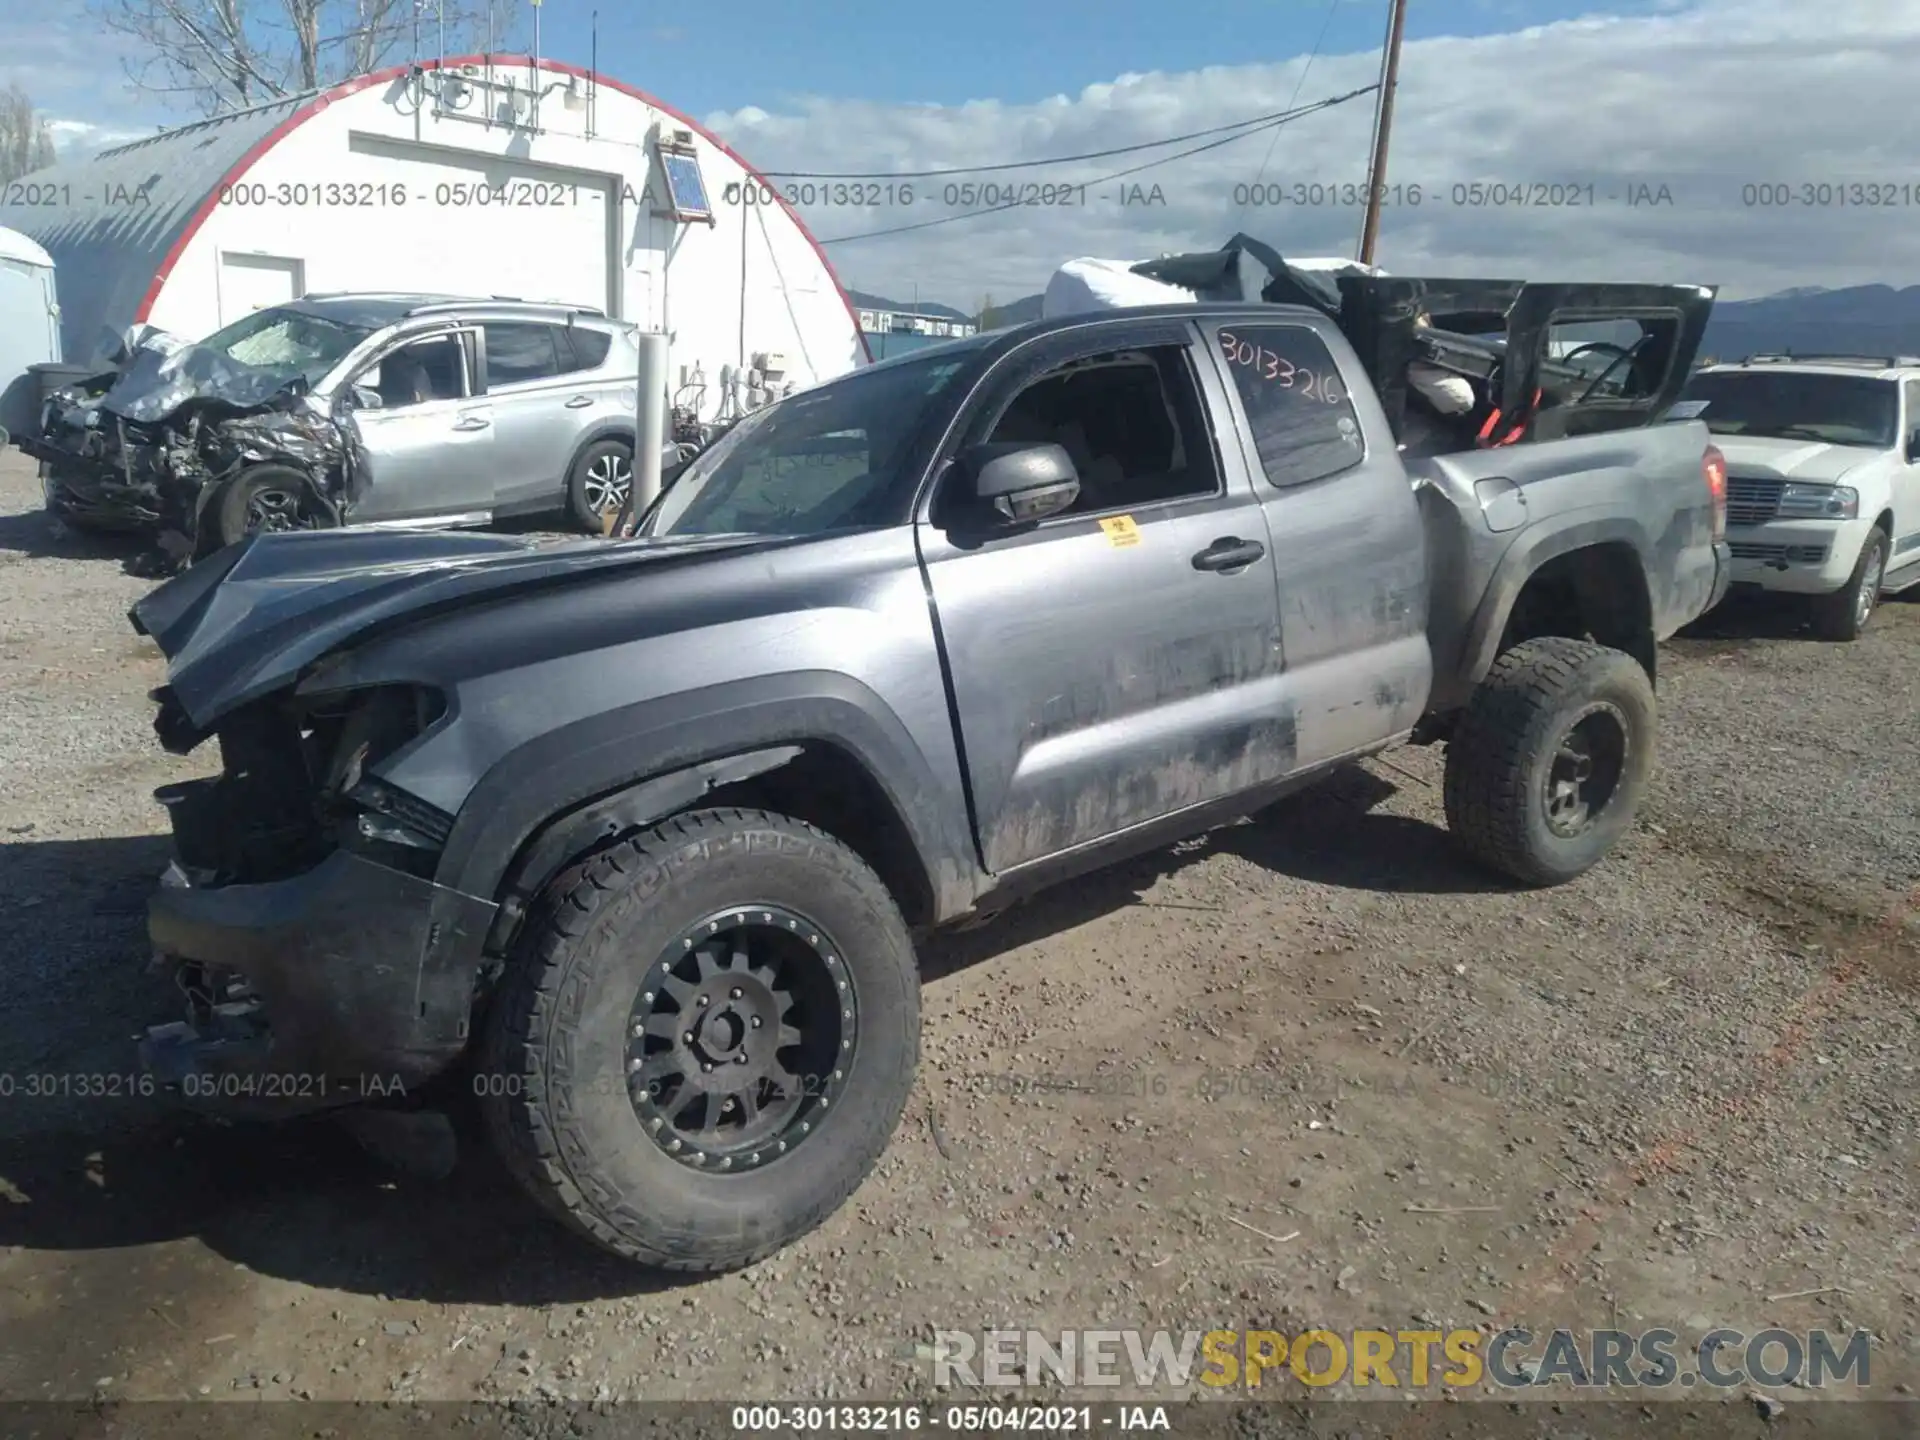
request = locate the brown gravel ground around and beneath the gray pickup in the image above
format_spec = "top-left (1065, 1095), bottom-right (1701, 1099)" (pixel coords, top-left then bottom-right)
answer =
top-left (0, 455), bottom-right (1920, 1405)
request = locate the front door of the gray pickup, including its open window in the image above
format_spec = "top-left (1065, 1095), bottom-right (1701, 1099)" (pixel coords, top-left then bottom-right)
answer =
top-left (920, 321), bottom-right (1294, 874)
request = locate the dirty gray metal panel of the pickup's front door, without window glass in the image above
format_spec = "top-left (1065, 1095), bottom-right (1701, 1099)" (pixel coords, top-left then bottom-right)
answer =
top-left (920, 324), bottom-right (1296, 874)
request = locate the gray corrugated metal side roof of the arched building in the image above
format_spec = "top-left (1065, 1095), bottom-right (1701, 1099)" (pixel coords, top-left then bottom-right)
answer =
top-left (0, 94), bottom-right (313, 363)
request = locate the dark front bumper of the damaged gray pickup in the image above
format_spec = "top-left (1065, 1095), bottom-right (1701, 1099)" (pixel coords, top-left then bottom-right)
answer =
top-left (140, 851), bottom-right (497, 1116)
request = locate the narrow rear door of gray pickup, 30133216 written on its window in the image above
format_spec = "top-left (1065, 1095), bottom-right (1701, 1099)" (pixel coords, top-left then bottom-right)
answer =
top-left (1202, 315), bottom-right (1432, 768)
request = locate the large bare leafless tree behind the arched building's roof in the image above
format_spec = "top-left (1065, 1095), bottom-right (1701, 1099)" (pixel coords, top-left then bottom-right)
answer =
top-left (88, 0), bottom-right (516, 115)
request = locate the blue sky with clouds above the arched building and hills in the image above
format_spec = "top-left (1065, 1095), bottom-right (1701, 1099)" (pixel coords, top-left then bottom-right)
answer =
top-left (0, 0), bottom-right (1920, 309)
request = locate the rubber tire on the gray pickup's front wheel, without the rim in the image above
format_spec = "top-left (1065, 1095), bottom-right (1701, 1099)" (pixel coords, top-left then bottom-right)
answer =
top-left (476, 810), bottom-right (920, 1271)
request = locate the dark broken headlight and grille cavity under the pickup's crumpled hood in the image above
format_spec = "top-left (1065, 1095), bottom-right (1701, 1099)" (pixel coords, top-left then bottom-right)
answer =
top-left (154, 685), bottom-right (453, 889)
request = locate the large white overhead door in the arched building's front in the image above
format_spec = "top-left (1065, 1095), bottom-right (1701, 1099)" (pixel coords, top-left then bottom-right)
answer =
top-left (345, 134), bottom-right (618, 313)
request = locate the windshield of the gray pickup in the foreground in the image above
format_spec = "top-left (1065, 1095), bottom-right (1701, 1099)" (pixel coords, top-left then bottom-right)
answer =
top-left (645, 346), bottom-right (973, 536)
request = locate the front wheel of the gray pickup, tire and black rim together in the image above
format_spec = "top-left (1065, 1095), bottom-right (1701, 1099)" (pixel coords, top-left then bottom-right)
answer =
top-left (474, 810), bottom-right (920, 1271)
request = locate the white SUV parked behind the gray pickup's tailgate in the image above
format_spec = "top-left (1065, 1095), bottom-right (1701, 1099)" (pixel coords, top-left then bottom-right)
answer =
top-left (1672, 355), bottom-right (1920, 639)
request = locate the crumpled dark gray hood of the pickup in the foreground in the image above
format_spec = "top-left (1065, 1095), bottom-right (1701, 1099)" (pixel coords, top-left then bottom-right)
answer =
top-left (129, 530), bottom-right (780, 739)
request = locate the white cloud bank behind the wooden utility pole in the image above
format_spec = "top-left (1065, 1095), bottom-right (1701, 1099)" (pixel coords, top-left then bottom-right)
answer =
top-left (710, 0), bottom-right (1920, 307)
